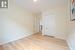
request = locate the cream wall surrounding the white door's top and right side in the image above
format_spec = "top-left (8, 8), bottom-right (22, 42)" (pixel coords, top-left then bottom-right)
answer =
top-left (42, 4), bottom-right (67, 39)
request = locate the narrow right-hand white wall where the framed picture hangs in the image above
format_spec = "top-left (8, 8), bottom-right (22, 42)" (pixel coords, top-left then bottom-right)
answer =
top-left (67, 0), bottom-right (75, 50)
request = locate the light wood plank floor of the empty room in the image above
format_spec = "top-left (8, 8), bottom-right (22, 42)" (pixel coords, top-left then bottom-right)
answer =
top-left (0, 33), bottom-right (69, 50)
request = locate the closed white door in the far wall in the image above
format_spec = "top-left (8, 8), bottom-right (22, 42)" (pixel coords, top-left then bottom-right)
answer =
top-left (42, 15), bottom-right (56, 36)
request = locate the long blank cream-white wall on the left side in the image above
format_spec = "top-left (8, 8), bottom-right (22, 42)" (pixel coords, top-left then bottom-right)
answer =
top-left (0, 0), bottom-right (35, 43)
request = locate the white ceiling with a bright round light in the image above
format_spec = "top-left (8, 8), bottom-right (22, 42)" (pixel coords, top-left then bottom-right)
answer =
top-left (16, 0), bottom-right (67, 13)
